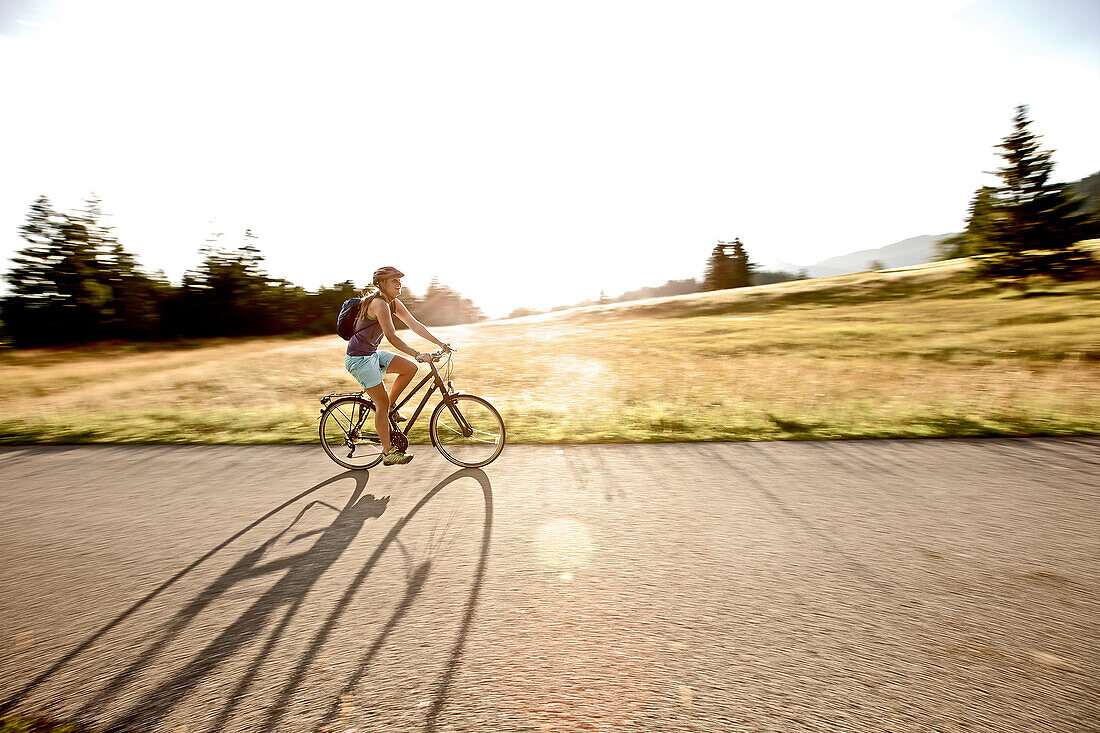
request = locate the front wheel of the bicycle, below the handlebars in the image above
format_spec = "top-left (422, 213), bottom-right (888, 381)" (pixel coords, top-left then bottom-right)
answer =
top-left (428, 394), bottom-right (505, 468)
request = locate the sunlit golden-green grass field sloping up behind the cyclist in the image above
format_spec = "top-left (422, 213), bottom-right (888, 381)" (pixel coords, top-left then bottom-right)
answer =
top-left (0, 261), bottom-right (1100, 444)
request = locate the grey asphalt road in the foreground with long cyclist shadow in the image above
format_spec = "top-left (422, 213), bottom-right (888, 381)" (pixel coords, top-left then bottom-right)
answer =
top-left (0, 439), bottom-right (1100, 733)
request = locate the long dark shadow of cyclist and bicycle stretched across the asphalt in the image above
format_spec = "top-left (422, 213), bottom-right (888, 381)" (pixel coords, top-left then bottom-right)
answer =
top-left (4, 469), bottom-right (492, 731)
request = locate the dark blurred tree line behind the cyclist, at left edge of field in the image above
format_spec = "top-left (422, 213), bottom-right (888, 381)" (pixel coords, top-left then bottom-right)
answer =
top-left (0, 196), bottom-right (484, 348)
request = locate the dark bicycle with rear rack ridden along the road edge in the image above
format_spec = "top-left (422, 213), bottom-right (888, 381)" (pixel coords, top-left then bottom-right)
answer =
top-left (318, 349), bottom-right (506, 469)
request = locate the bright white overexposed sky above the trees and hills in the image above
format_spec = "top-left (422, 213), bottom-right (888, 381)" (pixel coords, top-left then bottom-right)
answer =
top-left (0, 0), bottom-right (1100, 316)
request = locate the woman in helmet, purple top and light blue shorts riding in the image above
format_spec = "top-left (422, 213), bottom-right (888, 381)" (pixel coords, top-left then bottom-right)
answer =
top-left (344, 266), bottom-right (451, 466)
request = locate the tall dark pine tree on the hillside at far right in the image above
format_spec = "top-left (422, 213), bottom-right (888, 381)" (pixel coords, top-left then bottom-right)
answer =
top-left (967, 106), bottom-right (1100, 287)
